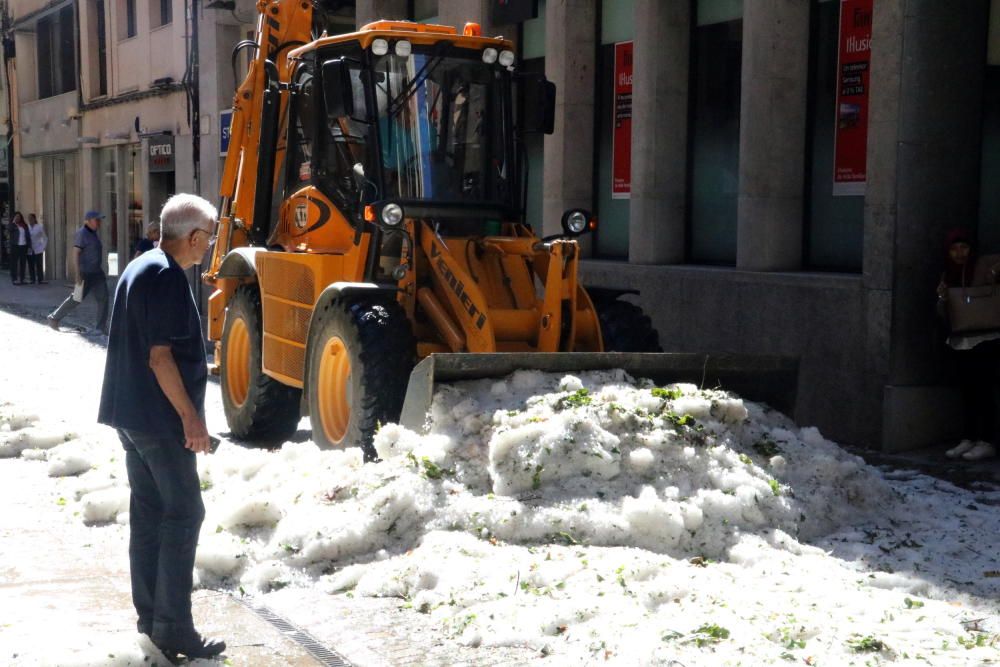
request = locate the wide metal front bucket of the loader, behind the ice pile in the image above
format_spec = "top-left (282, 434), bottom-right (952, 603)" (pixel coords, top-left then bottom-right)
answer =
top-left (399, 352), bottom-right (799, 431)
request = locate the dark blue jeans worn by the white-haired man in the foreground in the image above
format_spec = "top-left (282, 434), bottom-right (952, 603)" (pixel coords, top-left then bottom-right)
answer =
top-left (118, 429), bottom-right (205, 641)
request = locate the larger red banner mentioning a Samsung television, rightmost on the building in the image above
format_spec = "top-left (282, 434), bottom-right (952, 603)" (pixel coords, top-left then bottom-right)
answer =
top-left (833, 0), bottom-right (874, 196)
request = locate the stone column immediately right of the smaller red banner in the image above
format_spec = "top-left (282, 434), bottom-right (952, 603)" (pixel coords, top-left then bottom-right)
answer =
top-left (628, 0), bottom-right (691, 264)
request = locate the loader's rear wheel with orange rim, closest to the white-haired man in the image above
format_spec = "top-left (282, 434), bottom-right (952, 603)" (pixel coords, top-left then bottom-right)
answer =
top-left (220, 285), bottom-right (302, 443)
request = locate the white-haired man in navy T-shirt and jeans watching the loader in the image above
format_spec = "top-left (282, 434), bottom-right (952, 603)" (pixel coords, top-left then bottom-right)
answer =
top-left (98, 194), bottom-right (226, 660)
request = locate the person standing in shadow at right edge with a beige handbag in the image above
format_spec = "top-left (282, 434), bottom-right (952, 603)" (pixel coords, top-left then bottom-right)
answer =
top-left (937, 229), bottom-right (1000, 461)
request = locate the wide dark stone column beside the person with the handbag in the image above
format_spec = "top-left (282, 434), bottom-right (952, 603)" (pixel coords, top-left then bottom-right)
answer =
top-left (864, 0), bottom-right (989, 451)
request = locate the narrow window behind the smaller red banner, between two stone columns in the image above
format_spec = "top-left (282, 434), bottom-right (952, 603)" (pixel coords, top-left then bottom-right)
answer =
top-left (594, 0), bottom-right (635, 259)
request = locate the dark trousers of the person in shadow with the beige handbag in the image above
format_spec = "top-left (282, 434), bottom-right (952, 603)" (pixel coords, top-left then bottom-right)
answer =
top-left (951, 340), bottom-right (1000, 443)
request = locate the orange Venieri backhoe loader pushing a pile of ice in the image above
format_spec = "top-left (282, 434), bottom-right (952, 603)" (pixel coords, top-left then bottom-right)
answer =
top-left (203, 0), bottom-right (794, 458)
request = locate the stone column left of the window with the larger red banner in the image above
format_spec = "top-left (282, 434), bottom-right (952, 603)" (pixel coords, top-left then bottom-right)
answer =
top-left (736, 0), bottom-right (810, 271)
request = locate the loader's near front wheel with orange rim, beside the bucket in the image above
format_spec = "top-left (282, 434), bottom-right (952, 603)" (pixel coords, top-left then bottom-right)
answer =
top-left (306, 298), bottom-right (416, 461)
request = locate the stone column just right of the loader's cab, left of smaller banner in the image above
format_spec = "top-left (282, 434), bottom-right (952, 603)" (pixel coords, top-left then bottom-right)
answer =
top-left (542, 0), bottom-right (597, 235)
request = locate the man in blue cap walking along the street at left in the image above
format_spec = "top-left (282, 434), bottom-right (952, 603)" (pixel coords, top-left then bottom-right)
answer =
top-left (48, 211), bottom-right (108, 333)
